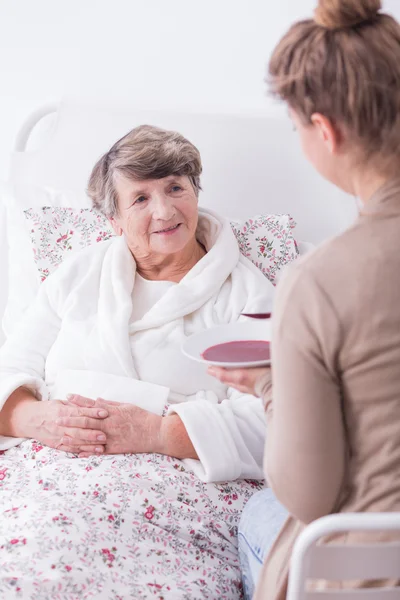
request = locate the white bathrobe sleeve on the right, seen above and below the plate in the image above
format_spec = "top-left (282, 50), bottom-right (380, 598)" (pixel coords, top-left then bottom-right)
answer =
top-left (169, 257), bottom-right (274, 482)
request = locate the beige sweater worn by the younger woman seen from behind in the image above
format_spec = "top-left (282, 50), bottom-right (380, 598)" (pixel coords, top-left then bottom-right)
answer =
top-left (255, 180), bottom-right (400, 600)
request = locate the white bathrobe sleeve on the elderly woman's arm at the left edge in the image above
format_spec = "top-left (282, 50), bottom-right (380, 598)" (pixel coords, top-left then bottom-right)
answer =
top-left (0, 282), bottom-right (61, 450)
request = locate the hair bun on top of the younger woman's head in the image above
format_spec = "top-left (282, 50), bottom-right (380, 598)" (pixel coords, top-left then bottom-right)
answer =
top-left (314, 0), bottom-right (382, 29)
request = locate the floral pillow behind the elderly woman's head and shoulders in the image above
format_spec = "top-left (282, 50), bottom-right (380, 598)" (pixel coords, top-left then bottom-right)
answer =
top-left (24, 207), bottom-right (298, 285)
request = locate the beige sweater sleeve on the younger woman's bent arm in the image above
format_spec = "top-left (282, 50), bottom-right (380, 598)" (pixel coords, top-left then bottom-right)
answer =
top-left (264, 265), bottom-right (346, 523)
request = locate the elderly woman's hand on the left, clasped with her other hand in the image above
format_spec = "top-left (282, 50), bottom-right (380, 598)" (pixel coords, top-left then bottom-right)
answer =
top-left (24, 400), bottom-right (108, 454)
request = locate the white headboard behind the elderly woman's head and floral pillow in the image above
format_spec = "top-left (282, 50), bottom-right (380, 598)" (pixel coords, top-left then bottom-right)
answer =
top-left (0, 102), bottom-right (356, 344)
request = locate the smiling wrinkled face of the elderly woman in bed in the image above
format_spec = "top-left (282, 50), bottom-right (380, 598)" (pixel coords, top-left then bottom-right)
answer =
top-left (111, 175), bottom-right (198, 258)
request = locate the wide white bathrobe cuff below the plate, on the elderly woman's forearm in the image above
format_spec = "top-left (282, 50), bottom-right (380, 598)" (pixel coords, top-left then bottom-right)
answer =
top-left (169, 389), bottom-right (265, 482)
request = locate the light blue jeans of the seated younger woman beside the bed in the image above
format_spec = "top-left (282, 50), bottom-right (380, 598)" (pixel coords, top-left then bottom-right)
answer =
top-left (238, 488), bottom-right (288, 600)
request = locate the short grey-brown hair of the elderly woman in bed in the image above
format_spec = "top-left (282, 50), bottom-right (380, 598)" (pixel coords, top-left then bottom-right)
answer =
top-left (88, 125), bottom-right (202, 217)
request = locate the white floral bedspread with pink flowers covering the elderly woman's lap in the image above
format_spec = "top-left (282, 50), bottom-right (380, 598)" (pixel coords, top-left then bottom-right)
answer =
top-left (0, 440), bottom-right (262, 600)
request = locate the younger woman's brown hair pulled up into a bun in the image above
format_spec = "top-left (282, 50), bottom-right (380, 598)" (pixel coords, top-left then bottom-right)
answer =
top-left (269, 0), bottom-right (400, 171)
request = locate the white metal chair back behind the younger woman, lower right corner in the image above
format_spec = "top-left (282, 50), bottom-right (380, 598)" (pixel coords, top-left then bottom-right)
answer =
top-left (287, 513), bottom-right (400, 600)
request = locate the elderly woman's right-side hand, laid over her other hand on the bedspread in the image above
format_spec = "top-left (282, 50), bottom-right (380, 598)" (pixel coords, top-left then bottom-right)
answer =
top-left (56, 396), bottom-right (162, 458)
